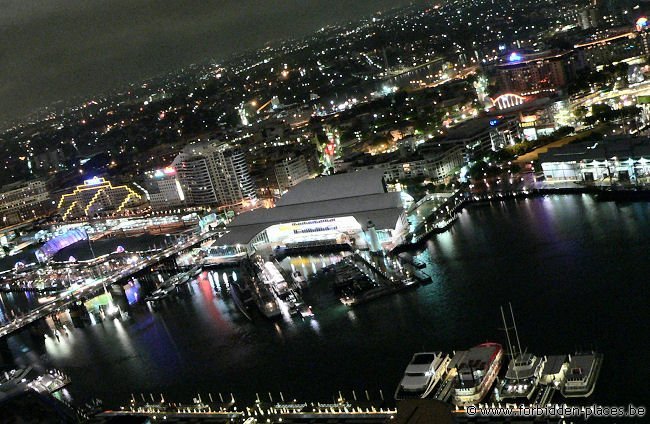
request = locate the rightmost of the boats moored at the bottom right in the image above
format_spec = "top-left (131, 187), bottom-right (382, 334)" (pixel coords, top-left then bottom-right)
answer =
top-left (560, 352), bottom-right (603, 398)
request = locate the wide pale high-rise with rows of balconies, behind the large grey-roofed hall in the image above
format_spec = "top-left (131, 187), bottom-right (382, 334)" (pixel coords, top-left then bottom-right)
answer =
top-left (172, 141), bottom-right (257, 207)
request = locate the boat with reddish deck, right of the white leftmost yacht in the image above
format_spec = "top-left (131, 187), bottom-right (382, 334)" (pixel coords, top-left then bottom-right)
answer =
top-left (453, 342), bottom-right (503, 406)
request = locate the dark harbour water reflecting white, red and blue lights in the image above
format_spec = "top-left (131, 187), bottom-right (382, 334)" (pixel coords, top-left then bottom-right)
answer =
top-left (1, 195), bottom-right (650, 406)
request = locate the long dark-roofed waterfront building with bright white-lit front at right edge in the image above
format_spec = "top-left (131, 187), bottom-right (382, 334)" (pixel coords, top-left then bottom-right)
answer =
top-left (539, 138), bottom-right (650, 184)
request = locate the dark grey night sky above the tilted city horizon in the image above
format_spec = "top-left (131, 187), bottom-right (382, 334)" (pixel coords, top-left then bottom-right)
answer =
top-left (0, 0), bottom-right (410, 122)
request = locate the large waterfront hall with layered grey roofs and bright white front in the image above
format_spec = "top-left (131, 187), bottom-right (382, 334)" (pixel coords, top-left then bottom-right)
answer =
top-left (212, 169), bottom-right (408, 256)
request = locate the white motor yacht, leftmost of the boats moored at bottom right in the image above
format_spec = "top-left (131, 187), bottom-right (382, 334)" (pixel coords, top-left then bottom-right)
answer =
top-left (395, 352), bottom-right (450, 400)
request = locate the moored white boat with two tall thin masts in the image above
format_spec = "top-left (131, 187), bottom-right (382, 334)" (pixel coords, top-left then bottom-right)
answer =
top-left (497, 353), bottom-right (546, 400)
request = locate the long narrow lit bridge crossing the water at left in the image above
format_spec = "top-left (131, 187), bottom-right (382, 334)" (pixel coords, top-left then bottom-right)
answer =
top-left (0, 232), bottom-right (217, 339)
